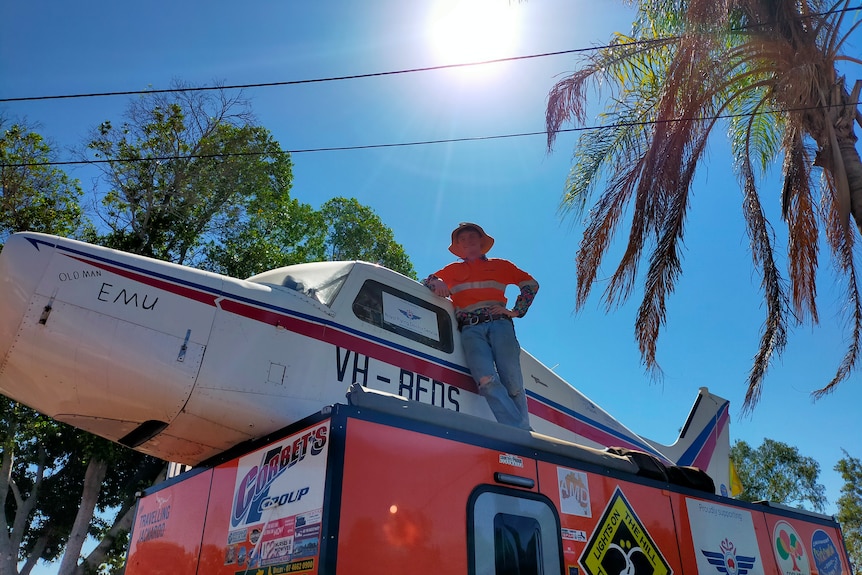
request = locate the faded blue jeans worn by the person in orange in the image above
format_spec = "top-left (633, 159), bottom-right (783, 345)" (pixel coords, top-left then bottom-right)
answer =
top-left (461, 319), bottom-right (530, 429)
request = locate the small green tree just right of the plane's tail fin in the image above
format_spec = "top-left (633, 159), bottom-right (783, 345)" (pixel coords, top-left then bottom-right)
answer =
top-left (730, 439), bottom-right (826, 512)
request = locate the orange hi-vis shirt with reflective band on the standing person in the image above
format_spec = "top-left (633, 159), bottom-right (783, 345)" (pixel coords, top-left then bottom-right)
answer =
top-left (432, 258), bottom-right (539, 316)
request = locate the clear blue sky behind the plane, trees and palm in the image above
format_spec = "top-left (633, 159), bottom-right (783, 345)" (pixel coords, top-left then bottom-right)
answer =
top-left (0, 0), bottom-right (862, 540)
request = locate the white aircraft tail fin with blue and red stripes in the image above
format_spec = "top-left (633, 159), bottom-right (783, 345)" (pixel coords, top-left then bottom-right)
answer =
top-left (646, 387), bottom-right (731, 496)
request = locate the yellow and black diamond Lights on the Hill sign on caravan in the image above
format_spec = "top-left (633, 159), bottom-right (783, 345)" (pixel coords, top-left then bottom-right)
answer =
top-left (580, 487), bottom-right (673, 575)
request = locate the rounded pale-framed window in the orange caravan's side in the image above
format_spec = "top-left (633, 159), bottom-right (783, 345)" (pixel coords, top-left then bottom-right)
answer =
top-left (467, 486), bottom-right (563, 575)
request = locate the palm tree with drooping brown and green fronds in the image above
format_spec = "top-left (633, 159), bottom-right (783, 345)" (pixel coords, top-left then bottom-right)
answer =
top-left (546, 0), bottom-right (862, 410)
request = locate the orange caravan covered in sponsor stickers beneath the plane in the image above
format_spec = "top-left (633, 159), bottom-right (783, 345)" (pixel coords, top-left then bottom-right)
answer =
top-left (126, 385), bottom-right (851, 575)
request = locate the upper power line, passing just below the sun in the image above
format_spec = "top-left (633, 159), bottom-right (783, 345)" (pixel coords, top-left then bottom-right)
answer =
top-left (0, 6), bottom-right (862, 103)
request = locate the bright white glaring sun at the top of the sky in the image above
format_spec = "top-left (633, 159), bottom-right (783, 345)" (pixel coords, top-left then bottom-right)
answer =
top-left (430, 0), bottom-right (518, 64)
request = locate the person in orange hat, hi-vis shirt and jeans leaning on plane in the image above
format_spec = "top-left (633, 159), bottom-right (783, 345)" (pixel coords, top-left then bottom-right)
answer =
top-left (422, 222), bottom-right (539, 429)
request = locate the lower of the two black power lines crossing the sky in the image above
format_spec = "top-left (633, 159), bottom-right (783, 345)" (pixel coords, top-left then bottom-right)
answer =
top-left (0, 102), bottom-right (862, 168)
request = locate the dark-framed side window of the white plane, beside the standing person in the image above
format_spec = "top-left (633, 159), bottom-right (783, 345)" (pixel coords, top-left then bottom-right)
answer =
top-left (353, 280), bottom-right (454, 353)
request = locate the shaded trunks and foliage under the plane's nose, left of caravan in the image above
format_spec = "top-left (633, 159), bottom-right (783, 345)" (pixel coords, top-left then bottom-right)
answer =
top-left (0, 398), bottom-right (165, 575)
